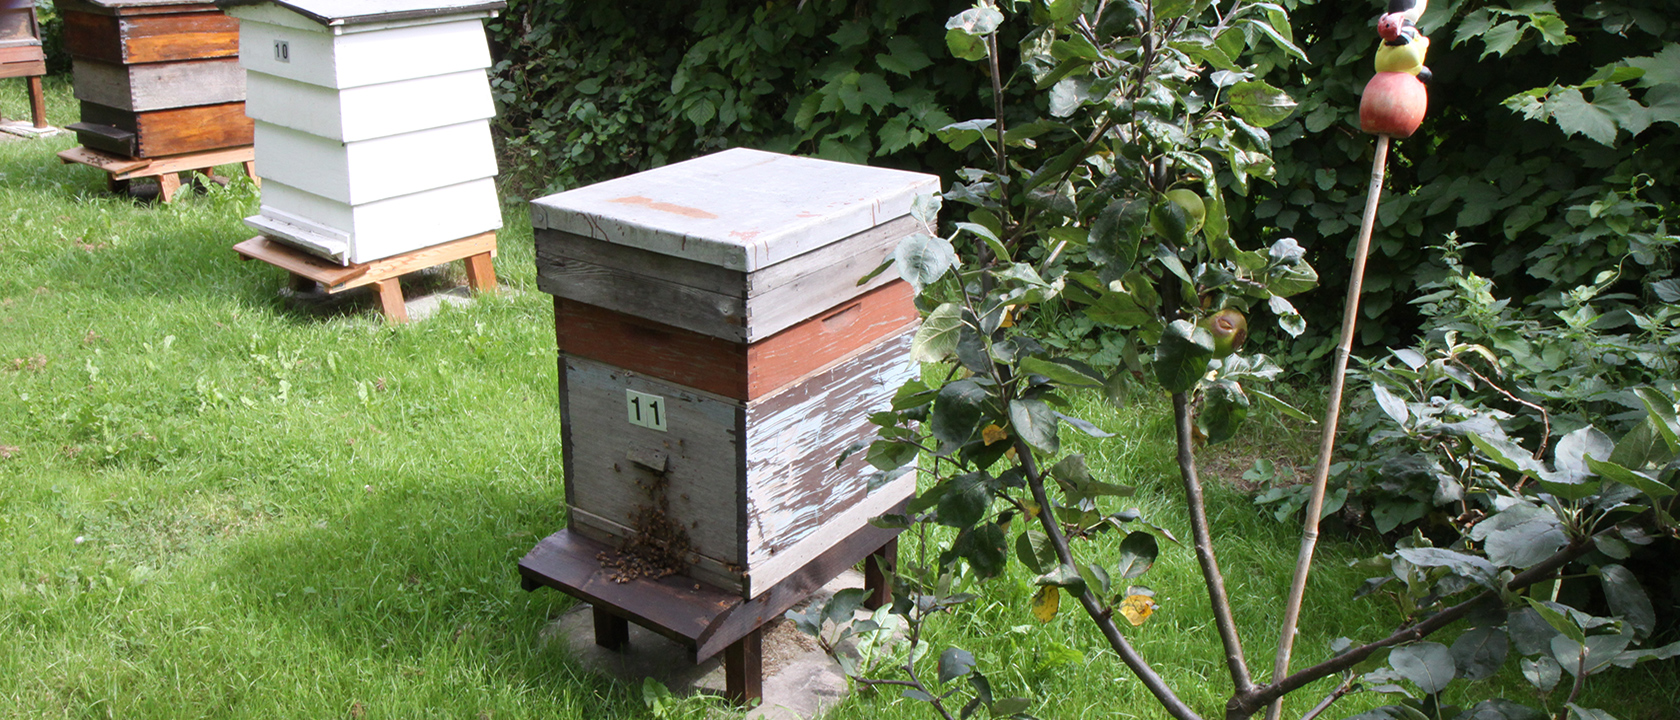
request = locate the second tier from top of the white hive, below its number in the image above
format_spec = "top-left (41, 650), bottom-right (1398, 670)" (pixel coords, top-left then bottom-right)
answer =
top-left (245, 70), bottom-right (496, 143)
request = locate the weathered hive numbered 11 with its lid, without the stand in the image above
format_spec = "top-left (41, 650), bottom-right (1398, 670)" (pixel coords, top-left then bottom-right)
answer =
top-left (531, 149), bottom-right (939, 599)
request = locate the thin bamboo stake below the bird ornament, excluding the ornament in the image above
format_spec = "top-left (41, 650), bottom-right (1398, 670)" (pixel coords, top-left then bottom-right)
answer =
top-left (1265, 134), bottom-right (1388, 720)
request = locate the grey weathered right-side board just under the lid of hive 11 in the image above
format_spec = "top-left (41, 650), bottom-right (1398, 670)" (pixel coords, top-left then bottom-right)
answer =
top-left (746, 215), bottom-right (924, 342)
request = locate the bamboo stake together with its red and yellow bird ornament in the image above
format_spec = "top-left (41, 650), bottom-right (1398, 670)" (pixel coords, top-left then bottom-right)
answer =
top-left (1267, 0), bottom-right (1430, 720)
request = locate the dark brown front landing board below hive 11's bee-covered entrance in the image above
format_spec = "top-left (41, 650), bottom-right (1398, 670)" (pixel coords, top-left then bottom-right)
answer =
top-left (519, 529), bottom-right (741, 655)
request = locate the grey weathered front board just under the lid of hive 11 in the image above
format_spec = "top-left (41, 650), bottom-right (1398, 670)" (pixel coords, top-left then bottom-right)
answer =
top-left (536, 243), bottom-right (746, 342)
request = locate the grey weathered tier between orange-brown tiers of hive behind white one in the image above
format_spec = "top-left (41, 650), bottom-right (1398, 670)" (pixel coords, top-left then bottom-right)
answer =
top-left (72, 57), bottom-right (245, 112)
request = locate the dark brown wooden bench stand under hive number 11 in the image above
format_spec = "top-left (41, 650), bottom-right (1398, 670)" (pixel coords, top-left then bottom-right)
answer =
top-left (519, 505), bottom-right (902, 703)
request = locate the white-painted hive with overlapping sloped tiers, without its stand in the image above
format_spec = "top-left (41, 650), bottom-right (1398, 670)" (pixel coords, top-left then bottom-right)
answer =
top-left (220, 0), bottom-right (504, 265)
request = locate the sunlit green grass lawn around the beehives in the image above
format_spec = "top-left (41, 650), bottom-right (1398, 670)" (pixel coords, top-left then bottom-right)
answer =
top-left (0, 79), bottom-right (1677, 720)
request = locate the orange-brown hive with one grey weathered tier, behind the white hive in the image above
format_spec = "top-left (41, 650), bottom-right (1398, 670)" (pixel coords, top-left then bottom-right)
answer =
top-left (57, 0), bottom-right (252, 158)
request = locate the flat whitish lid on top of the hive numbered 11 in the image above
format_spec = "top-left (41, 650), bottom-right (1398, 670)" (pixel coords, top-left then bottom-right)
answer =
top-left (531, 148), bottom-right (939, 272)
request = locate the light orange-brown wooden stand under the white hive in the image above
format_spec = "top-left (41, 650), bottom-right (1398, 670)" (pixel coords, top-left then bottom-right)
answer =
top-left (234, 232), bottom-right (496, 324)
